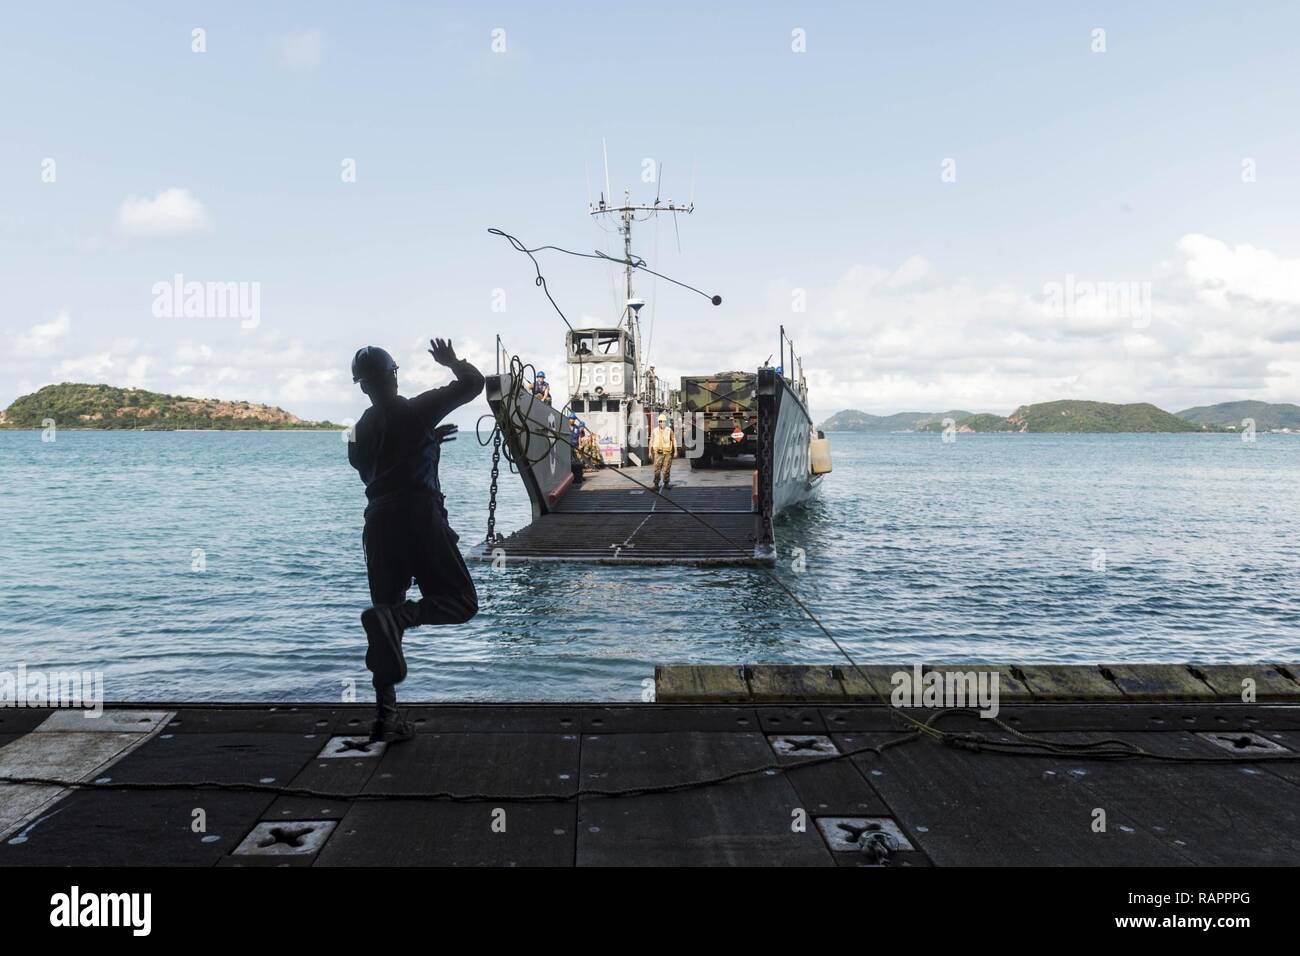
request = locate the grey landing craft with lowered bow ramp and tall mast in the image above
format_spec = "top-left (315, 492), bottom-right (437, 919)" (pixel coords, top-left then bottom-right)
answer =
top-left (472, 184), bottom-right (831, 566)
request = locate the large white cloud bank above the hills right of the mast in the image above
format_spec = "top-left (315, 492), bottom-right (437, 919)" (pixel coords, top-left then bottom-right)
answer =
top-left (651, 235), bottom-right (1300, 418)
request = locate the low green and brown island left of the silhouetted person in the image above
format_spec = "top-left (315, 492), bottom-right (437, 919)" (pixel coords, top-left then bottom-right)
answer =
top-left (0, 382), bottom-right (342, 432)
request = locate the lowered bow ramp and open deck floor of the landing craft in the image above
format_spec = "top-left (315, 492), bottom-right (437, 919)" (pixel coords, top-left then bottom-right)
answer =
top-left (485, 460), bottom-right (758, 563)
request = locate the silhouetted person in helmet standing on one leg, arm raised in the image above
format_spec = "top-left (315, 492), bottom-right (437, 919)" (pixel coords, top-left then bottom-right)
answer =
top-left (347, 338), bottom-right (484, 740)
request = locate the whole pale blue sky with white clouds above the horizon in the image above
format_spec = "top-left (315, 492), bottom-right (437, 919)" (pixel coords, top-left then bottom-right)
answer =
top-left (0, 0), bottom-right (1300, 423)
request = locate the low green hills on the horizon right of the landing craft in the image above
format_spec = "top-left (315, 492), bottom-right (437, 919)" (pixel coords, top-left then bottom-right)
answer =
top-left (819, 399), bottom-right (1300, 433)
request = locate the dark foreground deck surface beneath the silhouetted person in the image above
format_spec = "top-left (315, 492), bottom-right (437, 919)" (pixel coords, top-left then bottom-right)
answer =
top-left (0, 702), bottom-right (1300, 866)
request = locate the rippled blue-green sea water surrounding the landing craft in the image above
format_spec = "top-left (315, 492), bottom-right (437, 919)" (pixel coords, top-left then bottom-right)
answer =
top-left (0, 429), bottom-right (1300, 701)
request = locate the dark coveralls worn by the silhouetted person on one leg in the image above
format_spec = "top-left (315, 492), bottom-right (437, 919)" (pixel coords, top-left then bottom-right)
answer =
top-left (347, 362), bottom-right (484, 718)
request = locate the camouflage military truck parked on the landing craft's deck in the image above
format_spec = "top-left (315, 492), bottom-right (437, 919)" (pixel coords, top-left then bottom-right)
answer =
top-left (679, 372), bottom-right (758, 468)
